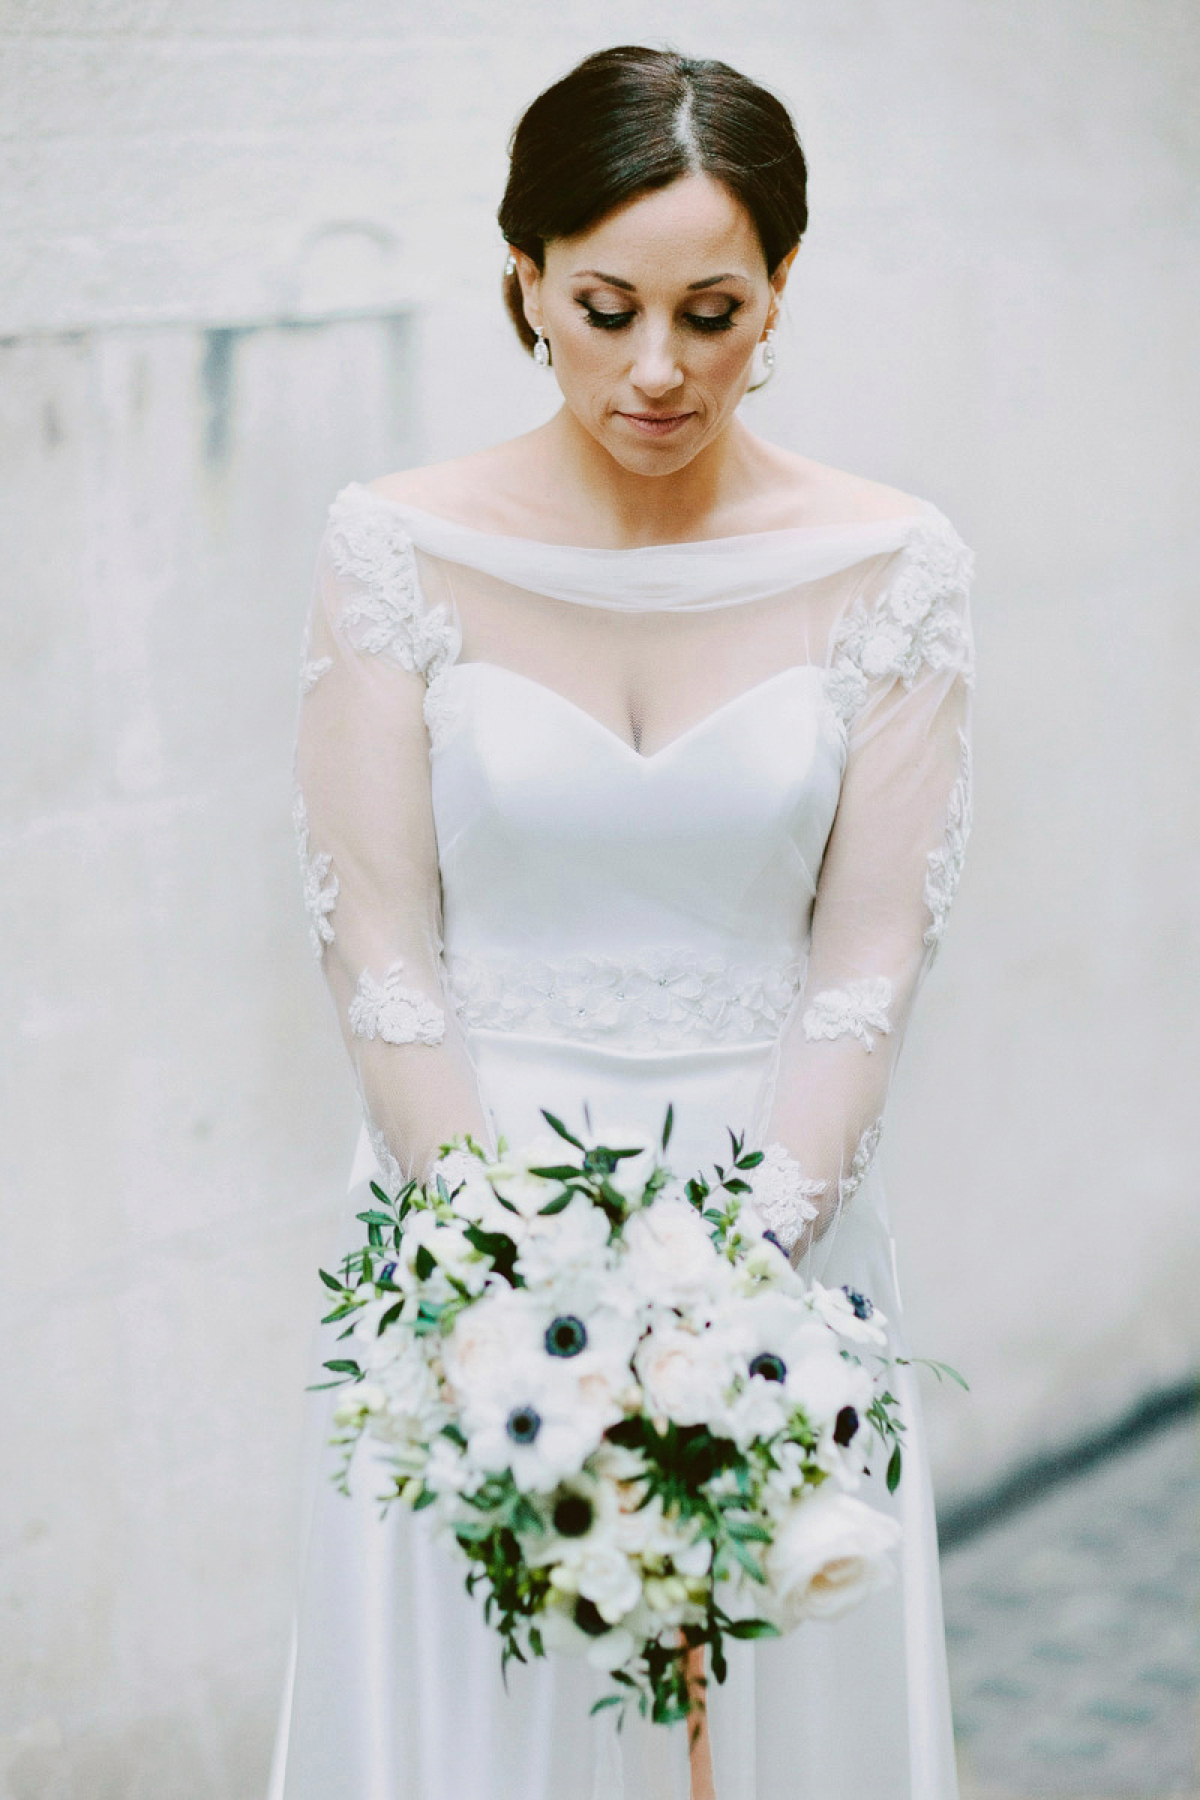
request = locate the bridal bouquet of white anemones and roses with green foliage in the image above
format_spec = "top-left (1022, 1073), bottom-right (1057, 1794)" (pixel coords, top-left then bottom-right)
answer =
top-left (320, 1109), bottom-right (903, 1724)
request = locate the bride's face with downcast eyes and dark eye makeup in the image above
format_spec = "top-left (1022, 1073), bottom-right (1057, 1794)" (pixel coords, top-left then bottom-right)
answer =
top-left (516, 175), bottom-right (795, 475)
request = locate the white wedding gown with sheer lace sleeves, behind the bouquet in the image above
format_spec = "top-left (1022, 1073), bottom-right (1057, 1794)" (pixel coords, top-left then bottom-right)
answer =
top-left (270, 484), bottom-right (972, 1800)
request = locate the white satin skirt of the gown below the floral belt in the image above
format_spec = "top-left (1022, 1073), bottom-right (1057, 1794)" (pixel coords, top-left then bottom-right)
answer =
top-left (268, 1031), bottom-right (957, 1800)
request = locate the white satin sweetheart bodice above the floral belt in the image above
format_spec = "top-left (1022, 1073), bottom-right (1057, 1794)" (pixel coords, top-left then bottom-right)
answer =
top-left (432, 662), bottom-right (846, 963)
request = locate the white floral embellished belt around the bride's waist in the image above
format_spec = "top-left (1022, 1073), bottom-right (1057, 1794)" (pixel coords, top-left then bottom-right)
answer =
top-left (444, 949), bottom-right (804, 1049)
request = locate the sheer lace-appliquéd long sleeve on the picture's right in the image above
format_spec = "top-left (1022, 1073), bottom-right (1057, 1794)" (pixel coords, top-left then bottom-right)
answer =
top-left (754, 515), bottom-right (973, 1273)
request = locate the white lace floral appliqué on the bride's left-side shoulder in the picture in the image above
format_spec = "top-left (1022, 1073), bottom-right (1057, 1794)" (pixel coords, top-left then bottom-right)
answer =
top-left (329, 486), bottom-right (462, 743)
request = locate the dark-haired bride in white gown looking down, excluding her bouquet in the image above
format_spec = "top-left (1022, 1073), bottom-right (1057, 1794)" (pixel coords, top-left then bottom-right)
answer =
top-left (272, 47), bottom-right (972, 1800)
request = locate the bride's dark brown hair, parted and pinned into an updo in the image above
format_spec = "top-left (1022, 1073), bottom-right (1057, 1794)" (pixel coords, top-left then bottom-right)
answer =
top-left (497, 45), bottom-right (808, 349)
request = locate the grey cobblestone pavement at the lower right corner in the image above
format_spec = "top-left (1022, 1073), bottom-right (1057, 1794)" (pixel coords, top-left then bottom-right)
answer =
top-left (943, 1415), bottom-right (1200, 1800)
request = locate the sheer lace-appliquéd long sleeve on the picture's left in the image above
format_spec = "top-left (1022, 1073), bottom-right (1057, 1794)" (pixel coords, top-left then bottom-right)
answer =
top-left (295, 495), bottom-right (491, 1184)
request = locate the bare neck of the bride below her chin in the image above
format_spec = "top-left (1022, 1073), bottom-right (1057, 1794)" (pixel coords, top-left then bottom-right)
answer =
top-left (543, 407), bottom-right (757, 549)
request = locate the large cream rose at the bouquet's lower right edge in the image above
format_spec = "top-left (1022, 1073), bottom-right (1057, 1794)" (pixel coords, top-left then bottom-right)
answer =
top-left (765, 1487), bottom-right (900, 1631)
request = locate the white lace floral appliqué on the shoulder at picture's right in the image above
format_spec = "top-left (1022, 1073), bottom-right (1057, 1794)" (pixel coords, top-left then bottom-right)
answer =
top-left (826, 515), bottom-right (975, 727)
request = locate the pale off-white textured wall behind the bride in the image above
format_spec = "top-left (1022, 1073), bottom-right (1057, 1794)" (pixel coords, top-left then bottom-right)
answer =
top-left (0, 0), bottom-right (1200, 1800)
